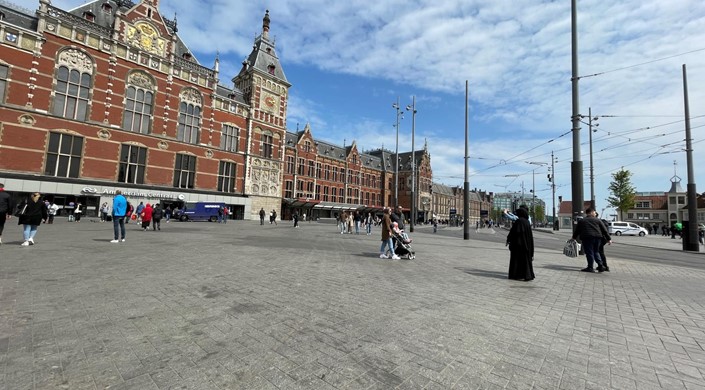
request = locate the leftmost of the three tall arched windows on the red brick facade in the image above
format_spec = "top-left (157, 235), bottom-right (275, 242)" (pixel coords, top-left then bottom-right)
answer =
top-left (52, 49), bottom-right (93, 120)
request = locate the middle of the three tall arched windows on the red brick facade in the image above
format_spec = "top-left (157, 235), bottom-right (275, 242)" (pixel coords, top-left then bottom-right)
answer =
top-left (122, 72), bottom-right (154, 134)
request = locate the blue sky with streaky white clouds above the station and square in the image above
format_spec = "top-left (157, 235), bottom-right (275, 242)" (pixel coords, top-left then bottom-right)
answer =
top-left (55, 0), bottom-right (705, 215)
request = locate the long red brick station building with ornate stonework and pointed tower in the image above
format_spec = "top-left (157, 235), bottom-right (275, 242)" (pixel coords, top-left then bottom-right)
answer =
top-left (0, 0), bottom-right (433, 220)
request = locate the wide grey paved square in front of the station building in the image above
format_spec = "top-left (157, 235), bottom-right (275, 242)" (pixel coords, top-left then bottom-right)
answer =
top-left (0, 219), bottom-right (705, 390)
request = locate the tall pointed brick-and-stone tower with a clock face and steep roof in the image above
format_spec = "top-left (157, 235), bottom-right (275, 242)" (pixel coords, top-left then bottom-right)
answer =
top-left (232, 10), bottom-right (291, 219)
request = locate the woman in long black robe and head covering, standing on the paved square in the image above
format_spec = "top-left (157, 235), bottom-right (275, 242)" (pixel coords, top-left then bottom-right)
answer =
top-left (507, 208), bottom-right (535, 282)
